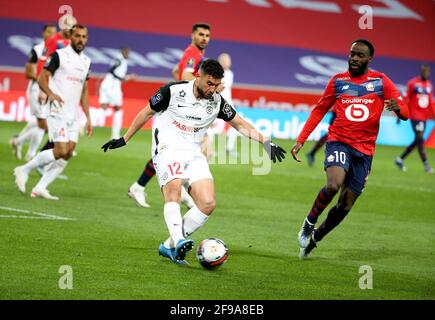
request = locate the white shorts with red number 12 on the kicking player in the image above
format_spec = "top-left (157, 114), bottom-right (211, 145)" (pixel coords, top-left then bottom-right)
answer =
top-left (153, 149), bottom-right (213, 188)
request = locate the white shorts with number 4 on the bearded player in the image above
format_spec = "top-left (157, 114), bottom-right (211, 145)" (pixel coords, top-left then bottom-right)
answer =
top-left (47, 115), bottom-right (80, 143)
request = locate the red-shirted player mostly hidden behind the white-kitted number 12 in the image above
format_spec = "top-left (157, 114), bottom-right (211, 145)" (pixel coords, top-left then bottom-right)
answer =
top-left (127, 23), bottom-right (210, 208)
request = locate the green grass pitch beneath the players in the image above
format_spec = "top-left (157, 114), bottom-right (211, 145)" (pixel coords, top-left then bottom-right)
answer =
top-left (0, 122), bottom-right (435, 300)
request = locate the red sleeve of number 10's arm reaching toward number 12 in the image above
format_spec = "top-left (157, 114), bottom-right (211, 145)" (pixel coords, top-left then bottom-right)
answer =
top-left (296, 78), bottom-right (336, 144)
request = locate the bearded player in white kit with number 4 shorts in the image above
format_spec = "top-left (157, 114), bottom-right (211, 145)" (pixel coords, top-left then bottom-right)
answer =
top-left (14, 24), bottom-right (92, 200)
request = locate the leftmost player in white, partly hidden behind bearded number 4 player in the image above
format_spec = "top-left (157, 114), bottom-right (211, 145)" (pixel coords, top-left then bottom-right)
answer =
top-left (10, 24), bottom-right (56, 161)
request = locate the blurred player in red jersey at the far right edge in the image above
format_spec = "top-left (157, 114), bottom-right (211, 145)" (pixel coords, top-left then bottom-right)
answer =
top-left (395, 65), bottom-right (434, 173)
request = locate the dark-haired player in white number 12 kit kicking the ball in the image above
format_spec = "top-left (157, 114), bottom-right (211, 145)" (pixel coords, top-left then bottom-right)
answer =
top-left (102, 59), bottom-right (285, 264)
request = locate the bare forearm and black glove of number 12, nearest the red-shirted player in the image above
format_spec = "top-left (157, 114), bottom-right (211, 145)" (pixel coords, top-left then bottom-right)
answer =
top-left (230, 114), bottom-right (286, 162)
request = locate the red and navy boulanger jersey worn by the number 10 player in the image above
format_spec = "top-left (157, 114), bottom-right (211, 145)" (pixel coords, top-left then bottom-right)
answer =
top-left (297, 70), bottom-right (407, 156)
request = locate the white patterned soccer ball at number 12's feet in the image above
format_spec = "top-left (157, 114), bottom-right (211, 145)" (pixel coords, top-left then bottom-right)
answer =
top-left (196, 238), bottom-right (228, 270)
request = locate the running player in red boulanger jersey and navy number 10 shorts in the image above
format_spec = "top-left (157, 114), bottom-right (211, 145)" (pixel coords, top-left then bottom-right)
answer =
top-left (291, 39), bottom-right (408, 259)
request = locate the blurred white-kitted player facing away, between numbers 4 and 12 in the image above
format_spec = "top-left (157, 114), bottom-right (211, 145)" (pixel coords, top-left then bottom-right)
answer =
top-left (99, 47), bottom-right (132, 139)
